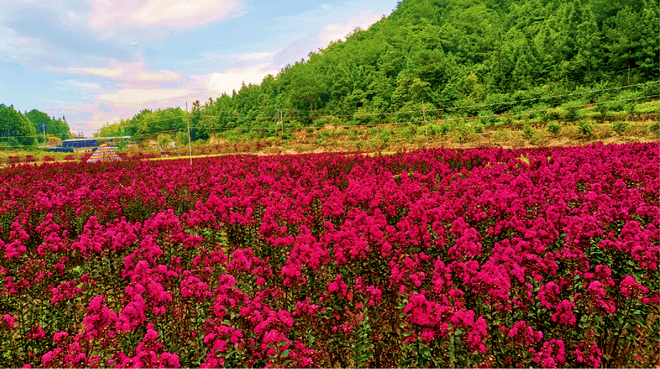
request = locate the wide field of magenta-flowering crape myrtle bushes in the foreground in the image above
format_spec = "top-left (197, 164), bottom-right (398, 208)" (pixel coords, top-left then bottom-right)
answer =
top-left (0, 143), bottom-right (660, 367)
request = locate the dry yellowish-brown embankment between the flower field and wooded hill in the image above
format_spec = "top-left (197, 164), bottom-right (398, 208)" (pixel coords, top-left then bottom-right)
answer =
top-left (250, 116), bottom-right (660, 155)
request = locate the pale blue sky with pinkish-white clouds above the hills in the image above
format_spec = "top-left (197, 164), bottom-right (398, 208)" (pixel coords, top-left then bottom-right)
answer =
top-left (0, 0), bottom-right (397, 136)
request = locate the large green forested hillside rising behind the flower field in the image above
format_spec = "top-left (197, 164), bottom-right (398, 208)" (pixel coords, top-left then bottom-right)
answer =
top-left (101, 0), bottom-right (660, 138)
